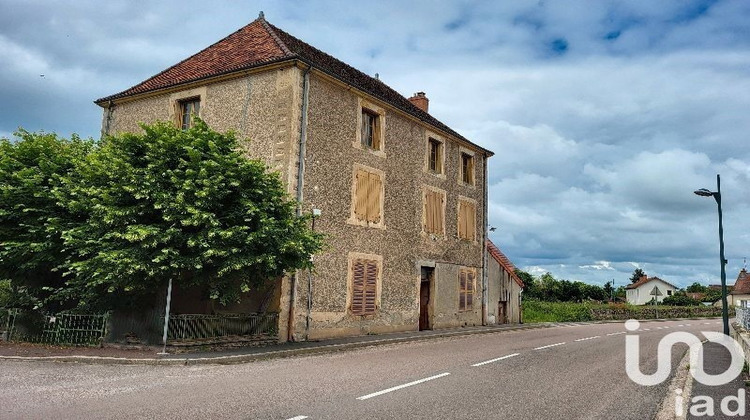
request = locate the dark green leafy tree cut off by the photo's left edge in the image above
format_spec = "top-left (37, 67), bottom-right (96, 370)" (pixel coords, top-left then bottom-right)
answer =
top-left (0, 130), bottom-right (94, 308)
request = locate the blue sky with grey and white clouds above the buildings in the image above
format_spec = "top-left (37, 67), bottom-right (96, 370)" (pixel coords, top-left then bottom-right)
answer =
top-left (0, 0), bottom-right (750, 286)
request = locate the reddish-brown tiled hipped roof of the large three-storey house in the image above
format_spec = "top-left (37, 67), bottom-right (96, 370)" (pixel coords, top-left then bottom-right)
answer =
top-left (94, 13), bottom-right (492, 156)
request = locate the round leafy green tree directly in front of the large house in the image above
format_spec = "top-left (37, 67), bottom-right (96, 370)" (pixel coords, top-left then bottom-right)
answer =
top-left (56, 119), bottom-right (322, 307)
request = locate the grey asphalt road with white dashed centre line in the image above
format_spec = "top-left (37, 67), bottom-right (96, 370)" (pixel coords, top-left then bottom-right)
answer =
top-left (0, 320), bottom-right (721, 420)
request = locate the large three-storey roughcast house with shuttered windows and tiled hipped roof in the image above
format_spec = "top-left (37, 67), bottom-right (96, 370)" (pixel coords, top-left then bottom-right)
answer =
top-left (95, 13), bottom-right (492, 341)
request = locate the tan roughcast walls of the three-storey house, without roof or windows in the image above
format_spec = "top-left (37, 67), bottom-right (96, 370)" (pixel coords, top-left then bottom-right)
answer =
top-left (98, 65), bottom-right (486, 341)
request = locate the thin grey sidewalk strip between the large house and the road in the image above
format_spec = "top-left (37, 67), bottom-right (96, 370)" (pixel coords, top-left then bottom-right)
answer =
top-left (0, 323), bottom-right (560, 365)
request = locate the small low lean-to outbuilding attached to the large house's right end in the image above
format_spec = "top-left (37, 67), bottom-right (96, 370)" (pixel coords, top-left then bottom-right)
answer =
top-left (487, 240), bottom-right (523, 324)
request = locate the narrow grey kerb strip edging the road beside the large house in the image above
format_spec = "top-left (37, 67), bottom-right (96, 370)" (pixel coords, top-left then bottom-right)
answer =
top-left (0, 324), bottom-right (554, 366)
